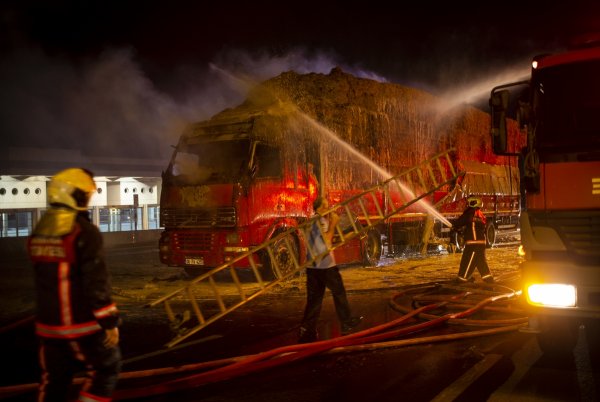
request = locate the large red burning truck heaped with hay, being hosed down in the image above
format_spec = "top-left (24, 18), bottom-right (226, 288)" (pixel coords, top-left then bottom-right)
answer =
top-left (159, 68), bottom-right (520, 275)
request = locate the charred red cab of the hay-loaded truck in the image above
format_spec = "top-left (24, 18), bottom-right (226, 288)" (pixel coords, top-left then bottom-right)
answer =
top-left (159, 119), bottom-right (317, 275)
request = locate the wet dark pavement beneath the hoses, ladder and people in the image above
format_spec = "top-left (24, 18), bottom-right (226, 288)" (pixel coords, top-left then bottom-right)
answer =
top-left (10, 240), bottom-right (597, 402)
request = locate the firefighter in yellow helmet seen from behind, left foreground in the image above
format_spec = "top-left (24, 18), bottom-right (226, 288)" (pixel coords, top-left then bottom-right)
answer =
top-left (28, 168), bottom-right (121, 402)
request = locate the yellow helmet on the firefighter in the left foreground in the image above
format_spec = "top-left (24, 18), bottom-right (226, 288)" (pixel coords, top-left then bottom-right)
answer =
top-left (48, 168), bottom-right (96, 211)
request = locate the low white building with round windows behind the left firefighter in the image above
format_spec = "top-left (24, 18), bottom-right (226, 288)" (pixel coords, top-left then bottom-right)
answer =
top-left (0, 148), bottom-right (166, 238)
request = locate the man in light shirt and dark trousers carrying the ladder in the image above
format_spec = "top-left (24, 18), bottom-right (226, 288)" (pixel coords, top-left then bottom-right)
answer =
top-left (298, 197), bottom-right (363, 343)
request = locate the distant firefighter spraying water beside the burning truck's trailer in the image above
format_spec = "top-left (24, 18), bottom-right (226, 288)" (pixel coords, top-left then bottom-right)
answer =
top-left (452, 196), bottom-right (494, 283)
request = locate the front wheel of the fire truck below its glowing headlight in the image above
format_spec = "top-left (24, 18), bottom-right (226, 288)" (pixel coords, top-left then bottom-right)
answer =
top-left (537, 317), bottom-right (579, 358)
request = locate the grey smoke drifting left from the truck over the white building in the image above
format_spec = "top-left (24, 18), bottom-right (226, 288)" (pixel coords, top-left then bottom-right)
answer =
top-left (0, 48), bottom-right (386, 158)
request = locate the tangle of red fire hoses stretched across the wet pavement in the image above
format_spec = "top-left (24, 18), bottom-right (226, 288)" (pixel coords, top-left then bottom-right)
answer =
top-left (0, 284), bottom-right (527, 400)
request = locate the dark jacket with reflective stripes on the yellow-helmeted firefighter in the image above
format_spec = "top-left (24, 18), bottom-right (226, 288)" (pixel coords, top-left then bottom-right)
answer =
top-left (28, 206), bottom-right (120, 339)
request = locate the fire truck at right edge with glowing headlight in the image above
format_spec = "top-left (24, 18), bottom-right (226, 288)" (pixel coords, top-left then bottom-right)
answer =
top-left (490, 36), bottom-right (600, 355)
